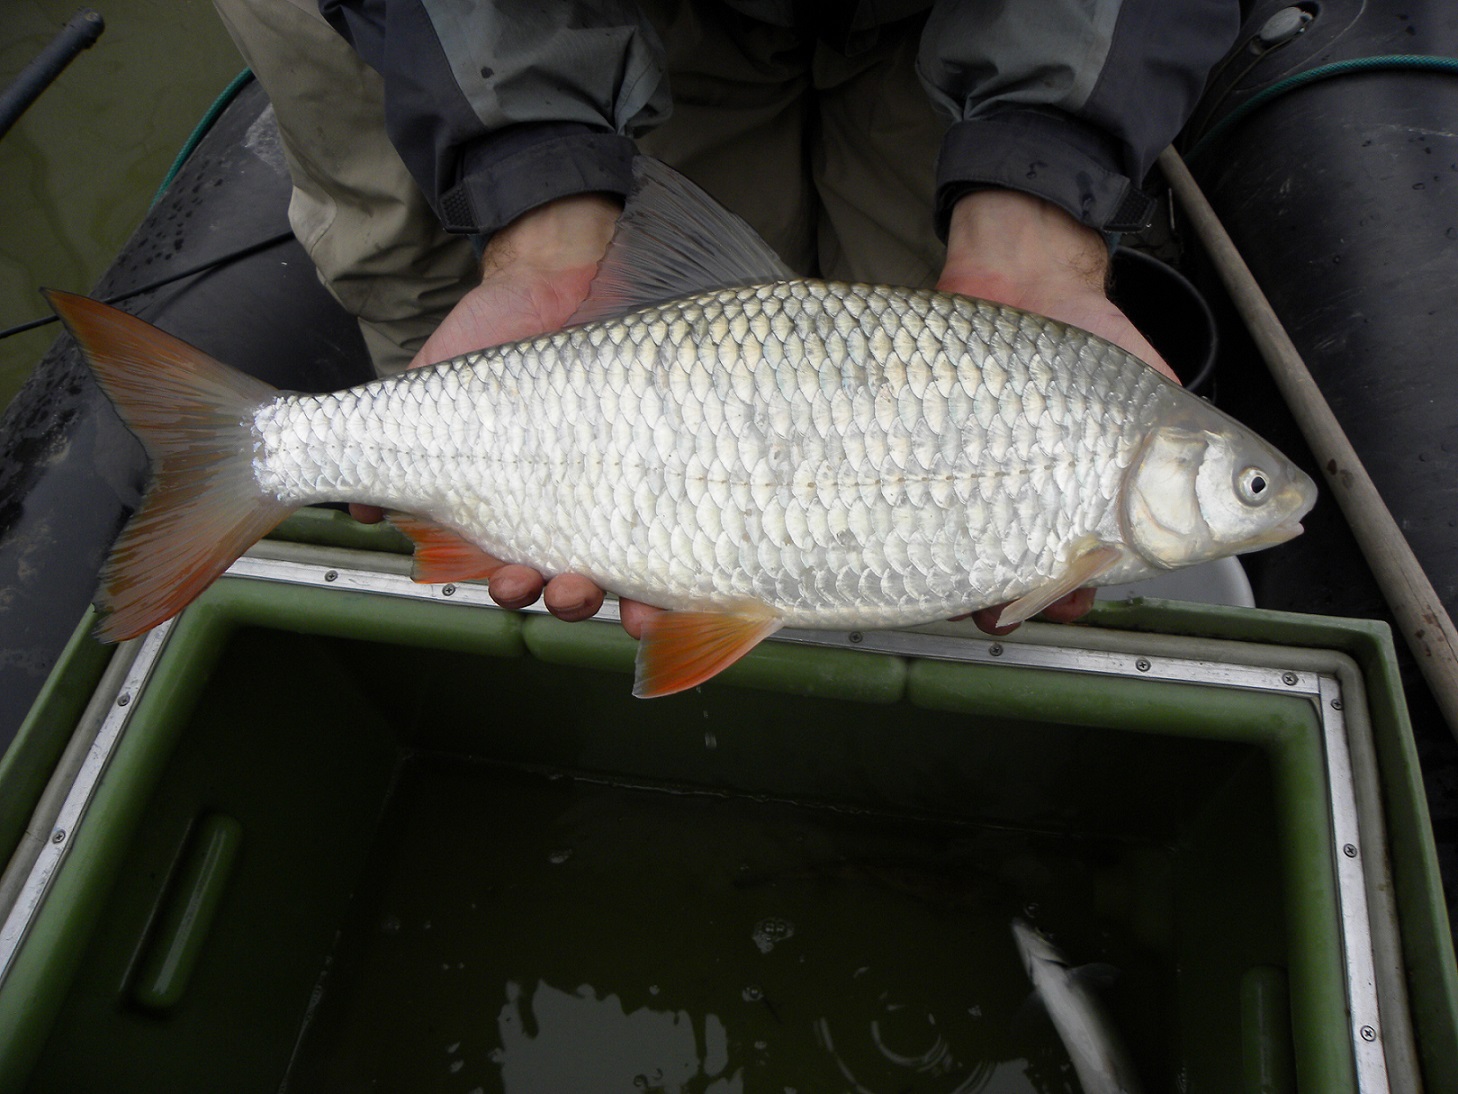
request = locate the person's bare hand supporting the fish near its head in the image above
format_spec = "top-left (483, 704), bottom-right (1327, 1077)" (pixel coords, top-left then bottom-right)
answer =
top-left (936, 190), bottom-right (1180, 635)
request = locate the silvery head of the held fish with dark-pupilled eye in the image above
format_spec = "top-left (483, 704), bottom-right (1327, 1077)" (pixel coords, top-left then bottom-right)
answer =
top-left (1123, 406), bottom-right (1317, 569)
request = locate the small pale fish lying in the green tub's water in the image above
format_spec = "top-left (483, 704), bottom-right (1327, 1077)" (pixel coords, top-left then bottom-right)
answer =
top-left (1012, 919), bottom-right (1140, 1094)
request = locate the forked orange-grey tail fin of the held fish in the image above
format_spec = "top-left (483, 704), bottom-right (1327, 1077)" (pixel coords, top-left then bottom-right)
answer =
top-left (45, 290), bottom-right (295, 642)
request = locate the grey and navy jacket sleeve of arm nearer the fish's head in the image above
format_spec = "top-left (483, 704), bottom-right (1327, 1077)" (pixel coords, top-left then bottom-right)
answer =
top-left (917, 0), bottom-right (1239, 238)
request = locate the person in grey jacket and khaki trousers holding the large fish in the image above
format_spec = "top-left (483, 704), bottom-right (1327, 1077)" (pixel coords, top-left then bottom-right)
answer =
top-left (214, 0), bottom-right (1239, 633)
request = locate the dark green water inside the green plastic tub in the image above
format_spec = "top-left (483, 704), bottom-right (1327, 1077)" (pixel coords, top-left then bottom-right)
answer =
top-left (286, 759), bottom-right (1172, 1094)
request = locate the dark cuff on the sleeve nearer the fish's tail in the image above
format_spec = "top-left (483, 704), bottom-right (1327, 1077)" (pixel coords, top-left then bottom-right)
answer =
top-left (436, 123), bottom-right (637, 235)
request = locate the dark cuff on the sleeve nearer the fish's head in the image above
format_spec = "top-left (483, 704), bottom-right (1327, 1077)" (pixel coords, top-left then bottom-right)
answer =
top-left (936, 111), bottom-right (1155, 242)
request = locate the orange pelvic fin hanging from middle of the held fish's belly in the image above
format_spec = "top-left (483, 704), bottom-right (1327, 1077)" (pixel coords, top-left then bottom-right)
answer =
top-left (633, 605), bottom-right (781, 699)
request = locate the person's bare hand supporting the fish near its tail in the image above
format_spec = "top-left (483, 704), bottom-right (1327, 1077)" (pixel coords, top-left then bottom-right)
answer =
top-left (350, 194), bottom-right (647, 636)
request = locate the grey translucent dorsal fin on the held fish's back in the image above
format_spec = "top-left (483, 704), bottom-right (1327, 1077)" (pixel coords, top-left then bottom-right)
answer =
top-left (567, 156), bottom-right (795, 327)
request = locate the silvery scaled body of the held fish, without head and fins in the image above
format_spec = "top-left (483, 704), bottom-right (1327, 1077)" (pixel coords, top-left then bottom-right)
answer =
top-left (254, 282), bottom-right (1177, 627)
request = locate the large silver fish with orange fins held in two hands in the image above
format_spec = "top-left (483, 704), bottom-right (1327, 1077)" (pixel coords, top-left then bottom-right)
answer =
top-left (48, 159), bottom-right (1315, 696)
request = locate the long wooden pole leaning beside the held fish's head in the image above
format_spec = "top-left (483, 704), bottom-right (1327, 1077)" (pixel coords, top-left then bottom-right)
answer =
top-left (1159, 147), bottom-right (1458, 738)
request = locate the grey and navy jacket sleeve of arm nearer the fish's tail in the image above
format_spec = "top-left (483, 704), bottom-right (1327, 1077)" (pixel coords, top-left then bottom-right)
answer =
top-left (319, 0), bottom-right (671, 233)
